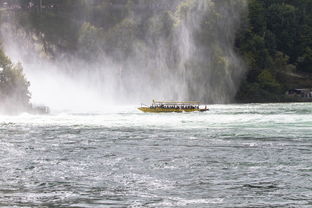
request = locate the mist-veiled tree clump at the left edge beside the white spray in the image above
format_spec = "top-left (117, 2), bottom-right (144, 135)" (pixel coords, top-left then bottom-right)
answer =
top-left (0, 50), bottom-right (30, 113)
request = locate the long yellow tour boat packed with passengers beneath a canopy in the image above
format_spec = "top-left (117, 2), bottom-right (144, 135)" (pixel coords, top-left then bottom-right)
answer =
top-left (138, 100), bottom-right (209, 113)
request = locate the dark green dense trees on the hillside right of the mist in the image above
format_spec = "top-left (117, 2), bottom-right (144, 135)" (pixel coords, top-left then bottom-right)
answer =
top-left (236, 0), bottom-right (312, 102)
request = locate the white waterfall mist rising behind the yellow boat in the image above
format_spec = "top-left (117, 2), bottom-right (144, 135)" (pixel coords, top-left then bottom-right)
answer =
top-left (1, 0), bottom-right (247, 110)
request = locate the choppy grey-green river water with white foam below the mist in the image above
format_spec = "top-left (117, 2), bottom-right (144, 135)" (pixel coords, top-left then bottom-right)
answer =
top-left (0, 103), bottom-right (312, 208)
